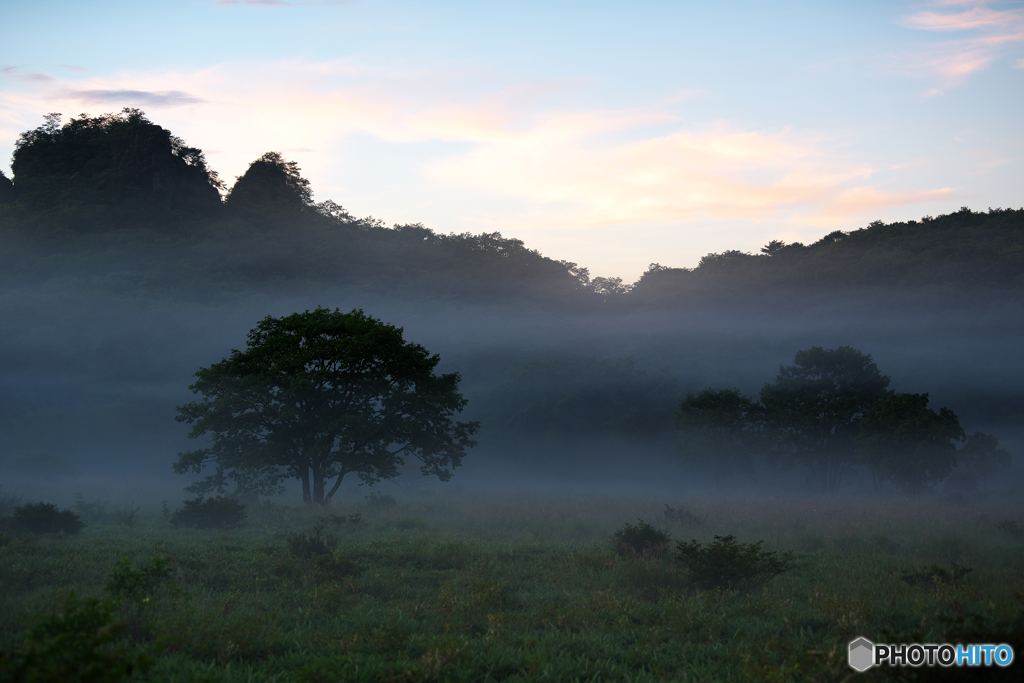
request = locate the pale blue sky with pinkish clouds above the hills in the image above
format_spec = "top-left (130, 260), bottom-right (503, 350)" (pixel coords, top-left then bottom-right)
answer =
top-left (0, 0), bottom-right (1024, 282)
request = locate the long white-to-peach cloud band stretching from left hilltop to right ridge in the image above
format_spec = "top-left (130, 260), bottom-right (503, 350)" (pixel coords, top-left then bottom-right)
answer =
top-left (0, 61), bottom-right (952, 235)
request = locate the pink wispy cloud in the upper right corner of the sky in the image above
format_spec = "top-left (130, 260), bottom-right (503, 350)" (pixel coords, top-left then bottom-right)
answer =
top-left (900, 0), bottom-right (1024, 90)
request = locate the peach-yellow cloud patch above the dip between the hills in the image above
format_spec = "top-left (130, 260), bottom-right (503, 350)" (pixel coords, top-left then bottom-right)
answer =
top-left (430, 116), bottom-right (951, 227)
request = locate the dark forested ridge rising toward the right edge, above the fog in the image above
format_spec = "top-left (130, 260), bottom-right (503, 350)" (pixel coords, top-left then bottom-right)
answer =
top-left (631, 207), bottom-right (1024, 303)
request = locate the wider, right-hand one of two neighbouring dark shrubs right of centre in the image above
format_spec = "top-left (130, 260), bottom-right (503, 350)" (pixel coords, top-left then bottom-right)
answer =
top-left (676, 535), bottom-right (793, 590)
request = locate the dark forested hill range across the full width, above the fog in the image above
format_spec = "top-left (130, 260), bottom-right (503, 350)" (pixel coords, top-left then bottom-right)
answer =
top-left (0, 110), bottom-right (1024, 308)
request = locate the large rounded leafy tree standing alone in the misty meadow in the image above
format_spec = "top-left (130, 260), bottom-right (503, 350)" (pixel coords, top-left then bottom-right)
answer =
top-left (174, 308), bottom-right (479, 505)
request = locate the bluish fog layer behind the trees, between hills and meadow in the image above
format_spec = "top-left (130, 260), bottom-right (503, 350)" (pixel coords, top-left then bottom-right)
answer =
top-left (0, 278), bottom-right (1024, 501)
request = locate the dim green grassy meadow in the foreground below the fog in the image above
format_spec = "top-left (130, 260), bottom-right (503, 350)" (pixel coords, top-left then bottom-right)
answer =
top-left (0, 495), bottom-right (1024, 683)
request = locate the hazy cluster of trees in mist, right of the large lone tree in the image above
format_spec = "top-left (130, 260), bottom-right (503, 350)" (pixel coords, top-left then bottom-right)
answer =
top-left (676, 346), bottom-right (1011, 496)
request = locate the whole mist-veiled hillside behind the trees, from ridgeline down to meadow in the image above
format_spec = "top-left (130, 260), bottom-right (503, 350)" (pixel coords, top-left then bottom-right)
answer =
top-left (0, 110), bottom-right (1024, 477)
